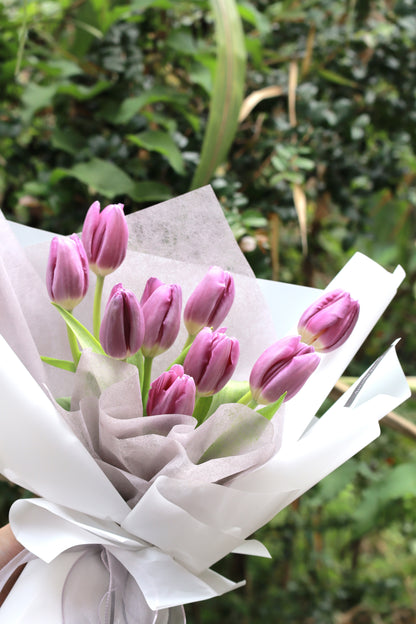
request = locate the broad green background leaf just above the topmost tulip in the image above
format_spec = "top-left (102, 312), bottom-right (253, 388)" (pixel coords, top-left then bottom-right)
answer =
top-left (51, 158), bottom-right (135, 198)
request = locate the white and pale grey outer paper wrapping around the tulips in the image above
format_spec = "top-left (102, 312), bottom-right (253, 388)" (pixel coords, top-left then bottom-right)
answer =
top-left (0, 187), bottom-right (409, 624)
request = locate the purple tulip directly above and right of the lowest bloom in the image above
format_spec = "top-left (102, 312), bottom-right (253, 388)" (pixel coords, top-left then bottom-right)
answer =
top-left (183, 327), bottom-right (240, 396)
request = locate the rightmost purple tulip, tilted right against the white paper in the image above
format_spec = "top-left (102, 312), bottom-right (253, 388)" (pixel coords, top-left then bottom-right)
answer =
top-left (298, 289), bottom-right (360, 353)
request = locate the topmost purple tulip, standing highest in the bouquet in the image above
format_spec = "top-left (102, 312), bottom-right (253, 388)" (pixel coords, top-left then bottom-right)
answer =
top-left (82, 201), bottom-right (129, 276)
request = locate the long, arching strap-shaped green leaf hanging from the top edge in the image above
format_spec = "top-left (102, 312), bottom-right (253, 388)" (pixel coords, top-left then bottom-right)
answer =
top-left (191, 0), bottom-right (246, 189)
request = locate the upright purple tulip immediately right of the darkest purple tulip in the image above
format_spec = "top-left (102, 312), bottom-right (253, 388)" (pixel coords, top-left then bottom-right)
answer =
top-left (140, 277), bottom-right (182, 358)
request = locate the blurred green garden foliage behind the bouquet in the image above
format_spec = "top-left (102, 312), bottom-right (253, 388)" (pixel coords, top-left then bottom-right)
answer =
top-left (0, 0), bottom-right (416, 624)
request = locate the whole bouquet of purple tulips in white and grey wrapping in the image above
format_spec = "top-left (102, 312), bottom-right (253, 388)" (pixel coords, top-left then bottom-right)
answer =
top-left (0, 188), bottom-right (408, 624)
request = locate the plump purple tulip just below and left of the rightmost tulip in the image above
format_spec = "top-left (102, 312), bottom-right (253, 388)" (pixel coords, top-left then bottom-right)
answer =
top-left (250, 336), bottom-right (320, 404)
